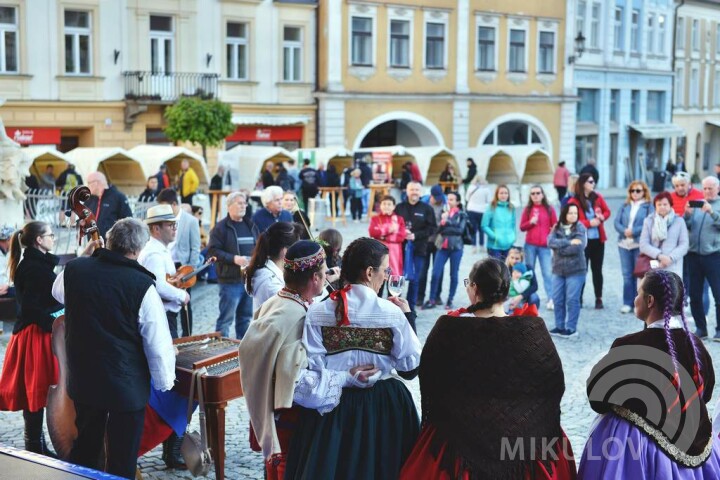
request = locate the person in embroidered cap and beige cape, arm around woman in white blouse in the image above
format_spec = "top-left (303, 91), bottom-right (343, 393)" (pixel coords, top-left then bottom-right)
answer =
top-left (240, 240), bottom-right (379, 480)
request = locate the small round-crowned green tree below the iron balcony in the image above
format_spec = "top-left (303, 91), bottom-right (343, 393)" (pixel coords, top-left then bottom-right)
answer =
top-left (164, 97), bottom-right (235, 163)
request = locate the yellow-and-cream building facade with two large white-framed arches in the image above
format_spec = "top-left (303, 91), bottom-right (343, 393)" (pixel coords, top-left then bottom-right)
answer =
top-left (316, 0), bottom-right (576, 181)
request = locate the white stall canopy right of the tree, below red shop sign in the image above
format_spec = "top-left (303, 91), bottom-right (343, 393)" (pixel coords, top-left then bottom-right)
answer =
top-left (218, 145), bottom-right (292, 191)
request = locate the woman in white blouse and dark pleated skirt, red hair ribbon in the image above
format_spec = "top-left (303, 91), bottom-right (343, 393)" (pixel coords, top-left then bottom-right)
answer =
top-left (285, 238), bottom-right (422, 480)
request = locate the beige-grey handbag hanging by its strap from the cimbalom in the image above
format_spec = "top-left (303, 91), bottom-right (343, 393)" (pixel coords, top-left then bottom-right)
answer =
top-left (180, 368), bottom-right (213, 477)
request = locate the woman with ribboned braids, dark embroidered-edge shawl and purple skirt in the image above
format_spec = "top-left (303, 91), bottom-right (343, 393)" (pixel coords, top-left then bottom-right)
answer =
top-left (578, 269), bottom-right (720, 480)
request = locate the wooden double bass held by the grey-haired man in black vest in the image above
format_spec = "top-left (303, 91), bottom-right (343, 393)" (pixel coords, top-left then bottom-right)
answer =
top-left (46, 185), bottom-right (100, 460)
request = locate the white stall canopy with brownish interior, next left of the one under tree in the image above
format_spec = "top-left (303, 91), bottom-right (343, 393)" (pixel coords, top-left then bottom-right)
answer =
top-left (65, 147), bottom-right (147, 196)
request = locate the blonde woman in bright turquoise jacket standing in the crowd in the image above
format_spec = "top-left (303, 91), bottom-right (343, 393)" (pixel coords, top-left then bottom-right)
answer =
top-left (482, 185), bottom-right (516, 261)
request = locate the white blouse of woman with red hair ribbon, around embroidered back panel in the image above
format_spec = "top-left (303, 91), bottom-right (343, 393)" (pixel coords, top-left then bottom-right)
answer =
top-left (303, 284), bottom-right (422, 379)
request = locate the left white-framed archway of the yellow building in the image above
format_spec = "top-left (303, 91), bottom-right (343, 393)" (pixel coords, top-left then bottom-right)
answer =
top-left (353, 112), bottom-right (445, 150)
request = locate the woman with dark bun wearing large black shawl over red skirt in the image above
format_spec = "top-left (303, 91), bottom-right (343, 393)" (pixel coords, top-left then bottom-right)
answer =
top-left (400, 257), bottom-right (575, 480)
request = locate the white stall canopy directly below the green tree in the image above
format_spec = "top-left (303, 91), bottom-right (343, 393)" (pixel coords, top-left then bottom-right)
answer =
top-left (130, 145), bottom-right (210, 189)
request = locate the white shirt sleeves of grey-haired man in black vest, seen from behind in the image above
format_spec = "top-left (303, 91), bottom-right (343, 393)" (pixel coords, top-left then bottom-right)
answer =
top-left (52, 271), bottom-right (175, 392)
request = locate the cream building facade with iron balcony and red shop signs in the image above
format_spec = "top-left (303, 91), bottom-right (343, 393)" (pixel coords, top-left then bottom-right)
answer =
top-left (0, 0), bottom-right (317, 169)
